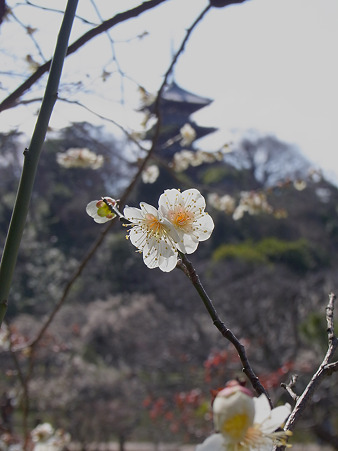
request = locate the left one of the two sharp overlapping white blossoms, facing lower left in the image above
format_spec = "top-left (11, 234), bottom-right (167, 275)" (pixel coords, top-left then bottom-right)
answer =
top-left (123, 202), bottom-right (180, 272)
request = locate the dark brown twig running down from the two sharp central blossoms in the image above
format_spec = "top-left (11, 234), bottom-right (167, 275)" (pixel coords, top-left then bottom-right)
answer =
top-left (177, 253), bottom-right (272, 407)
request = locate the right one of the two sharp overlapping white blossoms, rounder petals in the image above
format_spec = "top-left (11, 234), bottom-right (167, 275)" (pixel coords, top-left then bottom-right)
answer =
top-left (159, 188), bottom-right (214, 254)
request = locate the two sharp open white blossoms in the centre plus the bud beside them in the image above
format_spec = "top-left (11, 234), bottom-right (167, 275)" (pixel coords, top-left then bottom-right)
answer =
top-left (86, 188), bottom-right (214, 272)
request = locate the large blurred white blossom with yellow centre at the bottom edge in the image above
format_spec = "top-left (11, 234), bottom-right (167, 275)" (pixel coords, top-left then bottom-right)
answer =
top-left (196, 383), bottom-right (291, 451)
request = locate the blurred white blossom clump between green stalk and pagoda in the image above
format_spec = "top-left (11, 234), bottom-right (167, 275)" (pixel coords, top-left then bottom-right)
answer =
top-left (56, 148), bottom-right (104, 169)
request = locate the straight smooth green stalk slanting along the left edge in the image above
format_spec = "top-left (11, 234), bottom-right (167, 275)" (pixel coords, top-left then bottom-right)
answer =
top-left (0, 0), bottom-right (78, 325)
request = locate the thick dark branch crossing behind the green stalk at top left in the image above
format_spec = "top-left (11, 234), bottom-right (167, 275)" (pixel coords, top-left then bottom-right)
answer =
top-left (0, 0), bottom-right (168, 112)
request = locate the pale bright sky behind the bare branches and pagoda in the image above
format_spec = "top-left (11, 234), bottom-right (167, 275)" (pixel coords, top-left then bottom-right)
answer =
top-left (0, 0), bottom-right (338, 184)
